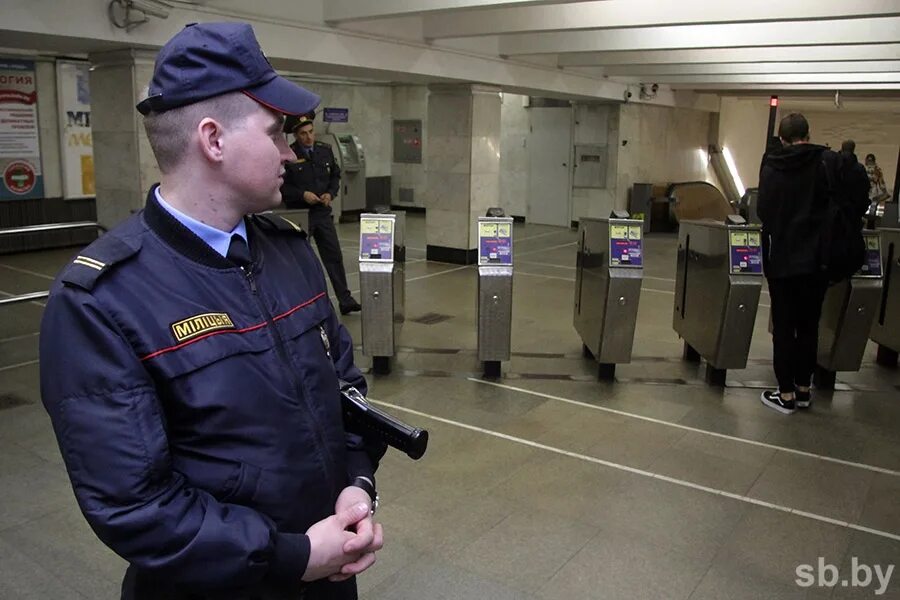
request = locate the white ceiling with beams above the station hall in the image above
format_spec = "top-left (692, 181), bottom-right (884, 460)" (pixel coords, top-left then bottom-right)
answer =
top-left (0, 0), bottom-right (900, 104)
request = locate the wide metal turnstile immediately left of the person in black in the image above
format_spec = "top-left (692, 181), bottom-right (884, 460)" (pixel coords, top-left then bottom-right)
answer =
top-left (672, 215), bottom-right (763, 385)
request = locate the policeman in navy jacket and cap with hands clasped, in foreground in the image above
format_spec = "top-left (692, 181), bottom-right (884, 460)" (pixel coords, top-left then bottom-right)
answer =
top-left (40, 23), bottom-right (385, 600)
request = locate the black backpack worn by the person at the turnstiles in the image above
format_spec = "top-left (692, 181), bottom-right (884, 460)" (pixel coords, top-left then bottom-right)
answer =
top-left (820, 154), bottom-right (866, 283)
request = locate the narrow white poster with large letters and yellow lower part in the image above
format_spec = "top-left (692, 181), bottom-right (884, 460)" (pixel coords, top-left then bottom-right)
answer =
top-left (56, 61), bottom-right (96, 199)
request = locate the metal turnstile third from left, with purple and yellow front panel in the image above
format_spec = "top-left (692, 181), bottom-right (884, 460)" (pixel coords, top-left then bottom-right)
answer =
top-left (574, 212), bottom-right (644, 379)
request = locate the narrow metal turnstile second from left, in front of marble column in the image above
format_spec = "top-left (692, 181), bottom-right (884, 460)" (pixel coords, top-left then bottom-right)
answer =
top-left (477, 217), bottom-right (513, 378)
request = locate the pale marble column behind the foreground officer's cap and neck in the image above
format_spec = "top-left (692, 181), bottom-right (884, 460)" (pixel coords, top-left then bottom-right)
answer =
top-left (88, 49), bottom-right (159, 227)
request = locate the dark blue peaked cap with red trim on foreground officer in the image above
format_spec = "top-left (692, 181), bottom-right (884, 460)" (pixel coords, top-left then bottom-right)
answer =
top-left (137, 23), bottom-right (321, 115)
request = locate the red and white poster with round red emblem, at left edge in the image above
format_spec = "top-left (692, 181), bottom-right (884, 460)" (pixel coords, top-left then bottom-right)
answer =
top-left (0, 59), bottom-right (44, 200)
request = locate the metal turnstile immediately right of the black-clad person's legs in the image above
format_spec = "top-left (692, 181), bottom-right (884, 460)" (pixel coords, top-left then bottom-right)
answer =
top-left (813, 231), bottom-right (882, 390)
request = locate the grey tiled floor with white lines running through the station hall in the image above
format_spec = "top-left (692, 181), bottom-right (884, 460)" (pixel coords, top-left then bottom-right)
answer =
top-left (0, 215), bottom-right (900, 600)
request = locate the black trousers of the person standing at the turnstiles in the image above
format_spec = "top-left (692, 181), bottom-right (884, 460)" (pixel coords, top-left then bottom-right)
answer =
top-left (769, 275), bottom-right (828, 393)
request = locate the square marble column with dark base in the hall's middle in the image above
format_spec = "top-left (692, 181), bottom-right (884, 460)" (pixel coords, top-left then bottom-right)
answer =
top-left (425, 84), bottom-right (500, 264)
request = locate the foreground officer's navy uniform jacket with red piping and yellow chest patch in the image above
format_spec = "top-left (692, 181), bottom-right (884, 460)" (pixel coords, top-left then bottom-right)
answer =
top-left (41, 190), bottom-right (384, 589)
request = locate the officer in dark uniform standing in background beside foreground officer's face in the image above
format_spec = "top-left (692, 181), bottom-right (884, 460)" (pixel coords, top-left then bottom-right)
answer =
top-left (281, 114), bottom-right (362, 315)
